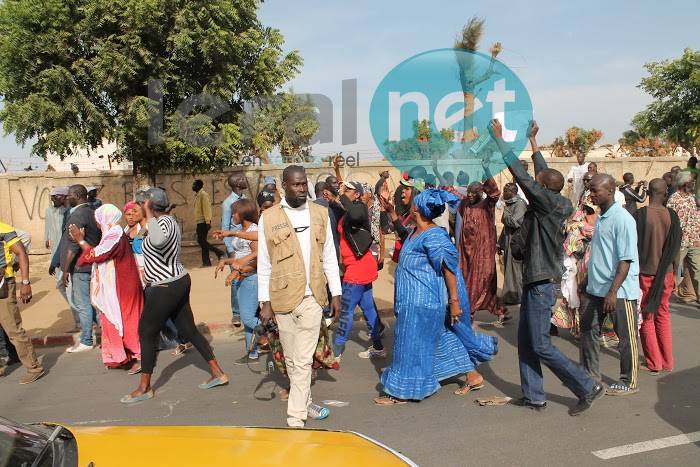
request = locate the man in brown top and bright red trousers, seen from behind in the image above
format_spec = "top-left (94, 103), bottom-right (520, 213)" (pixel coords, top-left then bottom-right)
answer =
top-left (634, 178), bottom-right (682, 374)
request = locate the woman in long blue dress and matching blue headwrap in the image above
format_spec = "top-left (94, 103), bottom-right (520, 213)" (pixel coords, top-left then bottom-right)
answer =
top-left (374, 188), bottom-right (498, 405)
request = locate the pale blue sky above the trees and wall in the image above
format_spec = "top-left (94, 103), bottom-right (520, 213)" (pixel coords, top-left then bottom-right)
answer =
top-left (0, 0), bottom-right (700, 168)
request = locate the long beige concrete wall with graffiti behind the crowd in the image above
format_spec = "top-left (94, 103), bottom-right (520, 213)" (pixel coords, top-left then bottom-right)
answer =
top-left (0, 154), bottom-right (686, 254)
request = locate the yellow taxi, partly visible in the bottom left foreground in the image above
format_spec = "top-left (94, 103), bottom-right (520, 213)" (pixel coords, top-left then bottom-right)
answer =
top-left (0, 417), bottom-right (416, 467)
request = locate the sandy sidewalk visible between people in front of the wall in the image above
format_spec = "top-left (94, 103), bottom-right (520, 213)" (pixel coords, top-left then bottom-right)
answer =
top-left (20, 248), bottom-right (394, 347)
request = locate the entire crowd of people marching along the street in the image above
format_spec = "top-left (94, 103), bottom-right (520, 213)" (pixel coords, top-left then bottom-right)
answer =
top-left (0, 120), bottom-right (700, 427)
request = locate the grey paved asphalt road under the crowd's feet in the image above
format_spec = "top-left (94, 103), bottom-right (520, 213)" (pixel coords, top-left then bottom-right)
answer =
top-left (0, 305), bottom-right (700, 466)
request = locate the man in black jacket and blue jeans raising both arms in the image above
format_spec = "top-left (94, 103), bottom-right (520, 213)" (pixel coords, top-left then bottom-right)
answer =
top-left (489, 120), bottom-right (603, 416)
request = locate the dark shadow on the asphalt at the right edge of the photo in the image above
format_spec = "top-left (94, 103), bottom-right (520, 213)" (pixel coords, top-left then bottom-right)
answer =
top-left (654, 366), bottom-right (700, 447)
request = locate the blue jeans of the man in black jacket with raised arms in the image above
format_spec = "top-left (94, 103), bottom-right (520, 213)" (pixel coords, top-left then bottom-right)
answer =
top-left (518, 282), bottom-right (595, 404)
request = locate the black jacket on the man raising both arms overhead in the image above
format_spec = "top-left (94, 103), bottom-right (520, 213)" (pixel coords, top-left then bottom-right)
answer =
top-left (503, 151), bottom-right (573, 286)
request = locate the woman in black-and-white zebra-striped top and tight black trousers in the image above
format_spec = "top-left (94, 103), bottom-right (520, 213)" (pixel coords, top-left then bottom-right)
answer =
top-left (121, 188), bottom-right (228, 404)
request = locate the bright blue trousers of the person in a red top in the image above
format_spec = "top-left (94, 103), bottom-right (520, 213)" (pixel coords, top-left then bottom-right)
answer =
top-left (333, 282), bottom-right (384, 356)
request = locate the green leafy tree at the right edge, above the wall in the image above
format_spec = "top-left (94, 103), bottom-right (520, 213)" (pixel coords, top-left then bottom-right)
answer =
top-left (632, 49), bottom-right (700, 152)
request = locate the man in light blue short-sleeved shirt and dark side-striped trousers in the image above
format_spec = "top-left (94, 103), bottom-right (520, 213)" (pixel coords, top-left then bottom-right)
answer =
top-left (581, 174), bottom-right (641, 396)
